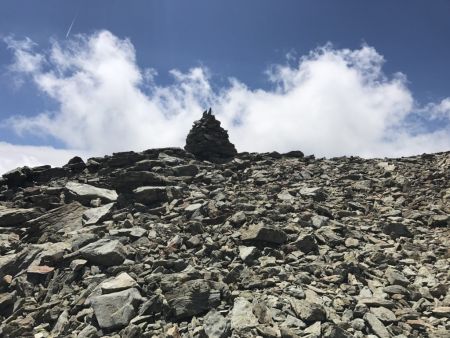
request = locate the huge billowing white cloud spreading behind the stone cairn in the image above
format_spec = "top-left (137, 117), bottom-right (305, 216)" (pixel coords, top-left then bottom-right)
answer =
top-left (2, 31), bottom-right (450, 170)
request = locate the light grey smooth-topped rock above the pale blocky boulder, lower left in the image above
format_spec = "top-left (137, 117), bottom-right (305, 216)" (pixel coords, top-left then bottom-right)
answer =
top-left (79, 239), bottom-right (126, 266)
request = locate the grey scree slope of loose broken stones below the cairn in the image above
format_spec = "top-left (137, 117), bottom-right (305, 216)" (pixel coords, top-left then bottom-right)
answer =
top-left (0, 114), bottom-right (450, 338)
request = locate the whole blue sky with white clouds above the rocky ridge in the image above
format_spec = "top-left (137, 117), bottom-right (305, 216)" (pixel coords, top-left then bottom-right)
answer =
top-left (0, 0), bottom-right (450, 172)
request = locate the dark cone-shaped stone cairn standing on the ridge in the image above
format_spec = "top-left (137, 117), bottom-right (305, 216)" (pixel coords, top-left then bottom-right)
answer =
top-left (184, 109), bottom-right (237, 163)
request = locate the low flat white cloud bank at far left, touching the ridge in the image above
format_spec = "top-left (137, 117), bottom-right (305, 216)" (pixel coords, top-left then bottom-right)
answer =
top-left (0, 142), bottom-right (87, 174)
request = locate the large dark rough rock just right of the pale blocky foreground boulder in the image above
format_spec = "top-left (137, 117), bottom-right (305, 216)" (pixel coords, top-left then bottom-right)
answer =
top-left (164, 279), bottom-right (221, 319)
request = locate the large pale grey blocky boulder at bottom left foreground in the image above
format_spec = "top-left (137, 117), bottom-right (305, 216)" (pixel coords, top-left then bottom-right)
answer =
top-left (91, 288), bottom-right (143, 330)
